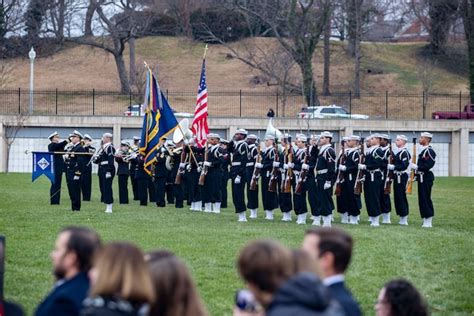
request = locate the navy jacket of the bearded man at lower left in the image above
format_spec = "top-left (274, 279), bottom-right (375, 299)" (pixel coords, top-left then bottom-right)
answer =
top-left (35, 272), bottom-right (89, 316)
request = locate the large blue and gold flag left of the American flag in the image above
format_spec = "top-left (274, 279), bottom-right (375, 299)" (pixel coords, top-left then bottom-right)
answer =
top-left (139, 69), bottom-right (178, 175)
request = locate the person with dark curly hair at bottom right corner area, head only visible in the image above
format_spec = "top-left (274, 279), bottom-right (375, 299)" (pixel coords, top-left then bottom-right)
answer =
top-left (375, 279), bottom-right (429, 316)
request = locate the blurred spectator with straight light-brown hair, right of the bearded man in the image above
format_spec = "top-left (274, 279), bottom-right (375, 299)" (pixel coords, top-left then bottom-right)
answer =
top-left (81, 242), bottom-right (154, 316)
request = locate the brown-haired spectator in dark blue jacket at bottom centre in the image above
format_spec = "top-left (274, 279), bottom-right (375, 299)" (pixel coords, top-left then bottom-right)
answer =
top-left (238, 241), bottom-right (344, 316)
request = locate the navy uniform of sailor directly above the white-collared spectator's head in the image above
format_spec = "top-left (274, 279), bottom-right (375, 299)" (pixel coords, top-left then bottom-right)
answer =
top-left (314, 144), bottom-right (336, 216)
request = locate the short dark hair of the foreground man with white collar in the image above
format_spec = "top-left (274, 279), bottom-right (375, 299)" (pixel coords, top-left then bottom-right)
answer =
top-left (306, 228), bottom-right (354, 273)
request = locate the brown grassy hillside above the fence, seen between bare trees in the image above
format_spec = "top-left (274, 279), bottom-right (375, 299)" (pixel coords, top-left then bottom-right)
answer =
top-left (0, 37), bottom-right (467, 93)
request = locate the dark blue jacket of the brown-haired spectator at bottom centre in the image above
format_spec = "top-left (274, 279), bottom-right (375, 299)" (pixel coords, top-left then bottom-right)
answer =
top-left (265, 272), bottom-right (344, 316)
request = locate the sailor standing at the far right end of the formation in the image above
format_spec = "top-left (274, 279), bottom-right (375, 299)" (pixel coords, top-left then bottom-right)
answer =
top-left (410, 132), bottom-right (436, 228)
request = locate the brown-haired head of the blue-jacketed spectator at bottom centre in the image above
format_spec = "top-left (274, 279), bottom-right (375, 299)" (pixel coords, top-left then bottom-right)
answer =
top-left (237, 240), bottom-right (295, 294)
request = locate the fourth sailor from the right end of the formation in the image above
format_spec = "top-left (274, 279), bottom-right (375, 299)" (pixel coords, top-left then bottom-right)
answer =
top-left (359, 134), bottom-right (383, 227)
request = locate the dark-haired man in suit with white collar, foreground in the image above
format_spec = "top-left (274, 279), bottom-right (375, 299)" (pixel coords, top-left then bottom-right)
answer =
top-left (302, 228), bottom-right (361, 316)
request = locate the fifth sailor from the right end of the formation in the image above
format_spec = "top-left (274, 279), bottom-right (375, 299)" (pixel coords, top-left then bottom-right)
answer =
top-left (339, 135), bottom-right (360, 225)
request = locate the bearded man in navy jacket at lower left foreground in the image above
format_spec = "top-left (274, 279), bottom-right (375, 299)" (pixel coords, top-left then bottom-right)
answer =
top-left (35, 227), bottom-right (101, 316)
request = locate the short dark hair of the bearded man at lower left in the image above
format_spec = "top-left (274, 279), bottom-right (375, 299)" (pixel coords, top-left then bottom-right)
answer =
top-left (61, 226), bottom-right (101, 273)
